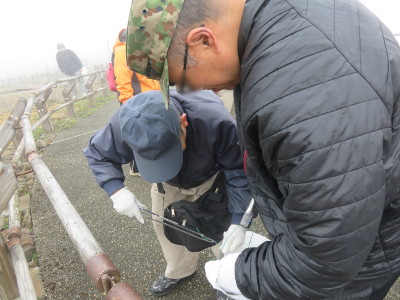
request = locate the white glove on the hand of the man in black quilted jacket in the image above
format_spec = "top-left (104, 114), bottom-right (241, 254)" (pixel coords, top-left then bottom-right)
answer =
top-left (205, 253), bottom-right (247, 300)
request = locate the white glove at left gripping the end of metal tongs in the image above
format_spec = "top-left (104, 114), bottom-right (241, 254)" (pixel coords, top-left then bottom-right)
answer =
top-left (110, 187), bottom-right (146, 224)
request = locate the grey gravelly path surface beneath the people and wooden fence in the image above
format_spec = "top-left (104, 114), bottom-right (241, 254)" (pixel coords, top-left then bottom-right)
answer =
top-left (31, 93), bottom-right (400, 300)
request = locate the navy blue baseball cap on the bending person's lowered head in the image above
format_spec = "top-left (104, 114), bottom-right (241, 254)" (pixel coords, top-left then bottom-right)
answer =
top-left (119, 91), bottom-right (183, 183)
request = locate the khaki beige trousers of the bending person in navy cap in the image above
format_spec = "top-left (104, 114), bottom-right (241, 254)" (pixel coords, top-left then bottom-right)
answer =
top-left (151, 175), bottom-right (219, 279)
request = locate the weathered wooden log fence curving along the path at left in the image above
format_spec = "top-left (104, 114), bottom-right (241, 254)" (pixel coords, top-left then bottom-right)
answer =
top-left (0, 71), bottom-right (142, 300)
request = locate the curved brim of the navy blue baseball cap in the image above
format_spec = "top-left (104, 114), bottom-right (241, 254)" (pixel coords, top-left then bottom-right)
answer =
top-left (133, 133), bottom-right (183, 183)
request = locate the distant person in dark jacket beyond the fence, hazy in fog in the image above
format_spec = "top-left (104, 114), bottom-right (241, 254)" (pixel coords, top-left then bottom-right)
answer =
top-left (56, 43), bottom-right (87, 94)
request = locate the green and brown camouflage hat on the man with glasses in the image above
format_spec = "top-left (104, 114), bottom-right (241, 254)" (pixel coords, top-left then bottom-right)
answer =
top-left (126, 0), bottom-right (185, 106)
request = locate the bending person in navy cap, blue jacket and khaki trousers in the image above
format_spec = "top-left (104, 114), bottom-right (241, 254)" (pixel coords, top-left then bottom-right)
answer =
top-left (84, 91), bottom-right (251, 296)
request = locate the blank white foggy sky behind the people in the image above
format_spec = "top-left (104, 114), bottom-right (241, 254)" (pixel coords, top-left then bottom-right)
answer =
top-left (0, 0), bottom-right (400, 78)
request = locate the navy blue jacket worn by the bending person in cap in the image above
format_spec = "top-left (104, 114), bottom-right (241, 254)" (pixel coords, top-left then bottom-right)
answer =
top-left (83, 91), bottom-right (251, 224)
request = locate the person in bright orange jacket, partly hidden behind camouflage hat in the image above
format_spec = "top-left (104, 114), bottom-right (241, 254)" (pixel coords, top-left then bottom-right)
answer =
top-left (111, 28), bottom-right (160, 104)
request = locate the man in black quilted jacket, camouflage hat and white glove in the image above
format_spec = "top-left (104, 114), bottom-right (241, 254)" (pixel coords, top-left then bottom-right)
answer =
top-left (128, 0), bottom-right (400, 300)
